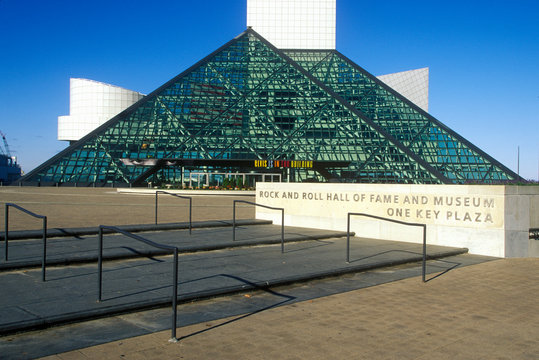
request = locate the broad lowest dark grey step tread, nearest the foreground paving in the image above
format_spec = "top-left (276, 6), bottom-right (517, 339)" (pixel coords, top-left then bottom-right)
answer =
top-left (0, 225), bottom-right (467, 335)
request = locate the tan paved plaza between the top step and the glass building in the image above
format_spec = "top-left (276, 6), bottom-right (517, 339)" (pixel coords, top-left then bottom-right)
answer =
top-left (0, 187), bottom-right (255, 230)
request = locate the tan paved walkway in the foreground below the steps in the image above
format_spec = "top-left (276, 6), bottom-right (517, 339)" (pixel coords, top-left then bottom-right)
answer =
top-left (41, 259), bottom-right (539, 360)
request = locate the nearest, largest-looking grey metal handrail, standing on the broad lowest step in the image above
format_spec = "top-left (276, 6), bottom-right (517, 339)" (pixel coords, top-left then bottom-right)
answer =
top-left (97, 225), bottom-right (178, 341)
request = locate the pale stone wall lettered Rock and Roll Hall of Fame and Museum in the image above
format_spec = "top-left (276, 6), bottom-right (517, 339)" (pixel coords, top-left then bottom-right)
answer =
top-left (256, 183), bottom-right (539, 257)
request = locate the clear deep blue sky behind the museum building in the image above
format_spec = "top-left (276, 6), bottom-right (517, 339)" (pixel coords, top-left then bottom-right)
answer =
top-left (0, 0), bottom-right (539, 180)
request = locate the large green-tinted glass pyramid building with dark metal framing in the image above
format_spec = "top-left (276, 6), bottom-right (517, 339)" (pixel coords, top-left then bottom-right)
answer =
top-left (20, 28), bottom-right (522, 186)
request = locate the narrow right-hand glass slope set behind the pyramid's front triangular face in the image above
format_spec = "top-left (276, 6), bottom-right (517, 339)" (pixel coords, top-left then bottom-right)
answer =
top-left (287, 51), bottom-right (517, 183)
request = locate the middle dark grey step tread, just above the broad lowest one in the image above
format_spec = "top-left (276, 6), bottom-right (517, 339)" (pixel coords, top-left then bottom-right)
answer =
top-left (0, 224), bottom-right (354, 272)
